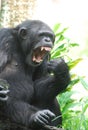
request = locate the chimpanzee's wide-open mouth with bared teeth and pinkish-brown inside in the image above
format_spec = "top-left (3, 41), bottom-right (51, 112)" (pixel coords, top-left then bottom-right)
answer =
top-left (32, 46), bottom-right (51, 63)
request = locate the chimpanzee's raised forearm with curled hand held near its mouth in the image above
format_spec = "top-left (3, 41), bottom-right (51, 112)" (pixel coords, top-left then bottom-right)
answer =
top-left (48, 59), bottom-right (70, 93)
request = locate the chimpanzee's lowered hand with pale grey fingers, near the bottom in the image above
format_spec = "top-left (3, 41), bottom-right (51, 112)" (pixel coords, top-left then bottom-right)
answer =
top-left (29, 109), bottom-right (55, 126)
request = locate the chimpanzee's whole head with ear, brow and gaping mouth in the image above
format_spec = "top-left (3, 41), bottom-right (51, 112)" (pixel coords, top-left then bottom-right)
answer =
top-left (17, 20), bottom-right (55, 66)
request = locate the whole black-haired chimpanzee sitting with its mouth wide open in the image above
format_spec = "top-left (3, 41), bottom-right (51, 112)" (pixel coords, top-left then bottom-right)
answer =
top-left (0, 20), bottom-right (70, 130)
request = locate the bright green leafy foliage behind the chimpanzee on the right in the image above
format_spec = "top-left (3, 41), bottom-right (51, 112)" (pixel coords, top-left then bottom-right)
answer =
top-left (51, 24), bottom-right (88, 130)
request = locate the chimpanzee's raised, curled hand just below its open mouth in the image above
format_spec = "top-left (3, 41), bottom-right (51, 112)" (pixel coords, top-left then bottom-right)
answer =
top-left (48, 58), bottom-right (69, 75)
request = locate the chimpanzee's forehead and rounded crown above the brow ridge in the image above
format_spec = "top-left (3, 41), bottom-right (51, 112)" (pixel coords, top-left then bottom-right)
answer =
top-left (18, 20), bottom-right (54, 36)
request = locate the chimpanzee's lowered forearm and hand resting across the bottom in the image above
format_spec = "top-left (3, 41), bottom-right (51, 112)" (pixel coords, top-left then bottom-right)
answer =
top-left (8, 101), bottom-right (55, 128)
